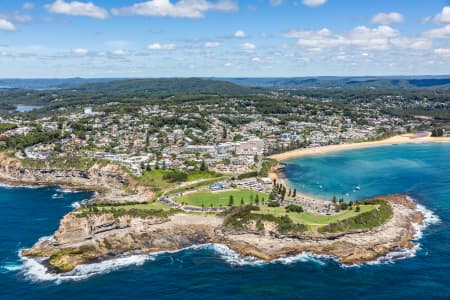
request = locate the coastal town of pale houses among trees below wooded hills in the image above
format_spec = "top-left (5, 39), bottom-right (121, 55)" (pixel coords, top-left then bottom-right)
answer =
top-left (0, 90), bottom-right (445, 176)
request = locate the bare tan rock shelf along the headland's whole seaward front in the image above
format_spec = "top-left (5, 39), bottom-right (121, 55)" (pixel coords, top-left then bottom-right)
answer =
top-left (22, 196), bottom-right (423, 271)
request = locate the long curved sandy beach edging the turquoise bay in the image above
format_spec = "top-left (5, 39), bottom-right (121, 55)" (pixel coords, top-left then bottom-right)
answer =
top-left (270, 133), bottom-right (450, 161)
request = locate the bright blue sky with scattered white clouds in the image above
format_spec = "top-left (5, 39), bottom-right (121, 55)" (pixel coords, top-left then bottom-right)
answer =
top-left (0, 0), bottom-right (450, 78)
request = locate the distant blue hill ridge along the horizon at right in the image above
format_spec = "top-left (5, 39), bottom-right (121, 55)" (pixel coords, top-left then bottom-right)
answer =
top-left (223, 76), bottom-right (450, 89)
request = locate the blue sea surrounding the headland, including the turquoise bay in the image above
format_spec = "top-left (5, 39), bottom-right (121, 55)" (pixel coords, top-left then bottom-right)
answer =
top-left (0, 144), bottom-right (450, 299)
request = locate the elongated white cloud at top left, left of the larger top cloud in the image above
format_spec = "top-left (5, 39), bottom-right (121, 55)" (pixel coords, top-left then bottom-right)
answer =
top-left (45, 0), bottom-right (109, 20)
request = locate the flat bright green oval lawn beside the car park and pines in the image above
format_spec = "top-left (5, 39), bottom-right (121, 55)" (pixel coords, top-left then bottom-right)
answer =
top-left (176, 189), bottom-right (269, 207)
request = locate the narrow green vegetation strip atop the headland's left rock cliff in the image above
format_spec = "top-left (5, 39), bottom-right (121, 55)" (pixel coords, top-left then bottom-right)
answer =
top-left (76, 202), bottom-right (179, 218)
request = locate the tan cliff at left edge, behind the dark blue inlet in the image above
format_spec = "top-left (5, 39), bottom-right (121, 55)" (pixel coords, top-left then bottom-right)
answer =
top-left (0, 153), bottom-right (154, 202)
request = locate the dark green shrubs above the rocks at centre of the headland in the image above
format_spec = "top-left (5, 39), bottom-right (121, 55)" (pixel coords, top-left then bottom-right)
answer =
top-left (223, 205), bottom-right (307, 234)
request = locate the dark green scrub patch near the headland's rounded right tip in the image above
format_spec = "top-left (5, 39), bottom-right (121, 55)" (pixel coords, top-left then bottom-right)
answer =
top-left (319, 199), bottom-right (393, 232)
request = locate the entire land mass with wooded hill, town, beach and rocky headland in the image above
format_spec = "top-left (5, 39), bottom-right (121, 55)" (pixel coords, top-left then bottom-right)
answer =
top-left (0, 78), bottom-right (449, 272)
